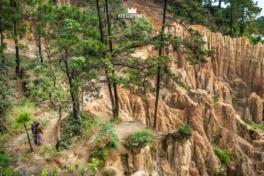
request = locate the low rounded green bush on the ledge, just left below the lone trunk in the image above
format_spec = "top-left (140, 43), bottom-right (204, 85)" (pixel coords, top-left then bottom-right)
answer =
top-left (128, 130), bottom-right (153, 147)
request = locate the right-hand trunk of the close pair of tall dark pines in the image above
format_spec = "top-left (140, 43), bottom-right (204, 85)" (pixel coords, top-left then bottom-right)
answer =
top-left (105, 0), bottom-right (119, 118)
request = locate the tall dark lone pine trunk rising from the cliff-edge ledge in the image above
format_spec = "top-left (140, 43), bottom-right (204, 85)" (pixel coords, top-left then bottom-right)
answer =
top-left (154, 0), bottom-right (167, 129)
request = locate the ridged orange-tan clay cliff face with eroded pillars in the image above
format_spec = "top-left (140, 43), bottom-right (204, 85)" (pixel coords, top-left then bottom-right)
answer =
top-left (84, 21), bottom-right (264, 176)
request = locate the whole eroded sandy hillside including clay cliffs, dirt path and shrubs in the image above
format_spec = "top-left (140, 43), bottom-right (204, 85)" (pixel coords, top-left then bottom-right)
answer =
top-left (0, 0), bottom-right (264, 176)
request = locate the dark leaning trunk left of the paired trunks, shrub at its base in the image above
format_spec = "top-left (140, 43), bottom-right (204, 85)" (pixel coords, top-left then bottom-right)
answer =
top-left (64, 59), bottom-right (80, 119)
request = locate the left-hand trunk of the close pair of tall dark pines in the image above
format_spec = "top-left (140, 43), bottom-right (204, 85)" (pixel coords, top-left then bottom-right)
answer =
top-left (96, 0), bottom-right (115, 116)
